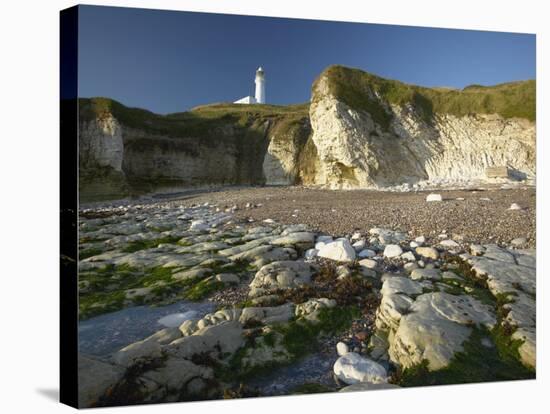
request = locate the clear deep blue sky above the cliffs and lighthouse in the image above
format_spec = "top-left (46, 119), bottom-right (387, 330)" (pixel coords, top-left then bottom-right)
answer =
top-left (79, 6), bottom-right (536, 113)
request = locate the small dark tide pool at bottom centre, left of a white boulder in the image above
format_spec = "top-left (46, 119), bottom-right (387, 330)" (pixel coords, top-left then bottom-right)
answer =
top-left (247, 352), bottom-right (338, 395)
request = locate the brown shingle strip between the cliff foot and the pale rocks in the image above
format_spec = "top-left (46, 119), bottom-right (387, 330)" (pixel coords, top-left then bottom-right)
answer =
top-left (165, 187), bottom-right (536, 247)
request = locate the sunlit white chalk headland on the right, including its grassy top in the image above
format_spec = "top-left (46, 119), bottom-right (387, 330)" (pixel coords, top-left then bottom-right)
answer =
top-left (310, 67), bottom-right (535, 188)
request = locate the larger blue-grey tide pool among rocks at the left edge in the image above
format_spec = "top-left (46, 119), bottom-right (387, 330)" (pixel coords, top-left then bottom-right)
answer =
top-left (78, 301), bottom-right (214, 356)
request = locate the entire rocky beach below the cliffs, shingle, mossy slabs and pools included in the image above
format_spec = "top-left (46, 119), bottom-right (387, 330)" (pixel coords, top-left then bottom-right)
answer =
top-left (79, 185), bottom-right (536, 406)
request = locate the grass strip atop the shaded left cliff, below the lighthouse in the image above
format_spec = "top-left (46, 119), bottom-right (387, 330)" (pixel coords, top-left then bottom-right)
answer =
top-left (79, 97), bottom-right (309, 138)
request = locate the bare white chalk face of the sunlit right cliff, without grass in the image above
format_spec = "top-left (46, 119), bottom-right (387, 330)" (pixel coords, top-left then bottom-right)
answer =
top-left (310, 69), bottom-right (535, 188)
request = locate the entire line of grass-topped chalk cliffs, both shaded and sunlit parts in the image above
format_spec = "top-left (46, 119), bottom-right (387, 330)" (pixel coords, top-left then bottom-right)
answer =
top-left (79, 66), bottom-right (535, 200)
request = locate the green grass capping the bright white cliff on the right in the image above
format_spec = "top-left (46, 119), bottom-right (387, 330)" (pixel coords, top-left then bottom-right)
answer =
top-left (322, 65), bottom-right (536, 129)
